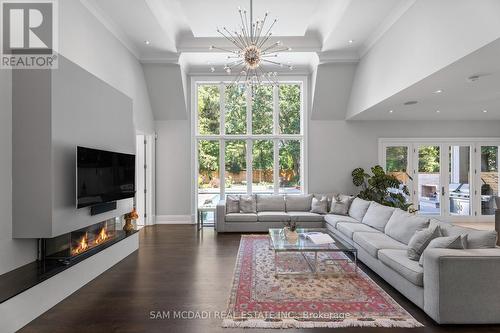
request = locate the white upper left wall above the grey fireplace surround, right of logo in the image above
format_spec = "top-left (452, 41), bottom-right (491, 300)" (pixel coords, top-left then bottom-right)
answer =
top-left (59, 0), bottom-right (154, 134)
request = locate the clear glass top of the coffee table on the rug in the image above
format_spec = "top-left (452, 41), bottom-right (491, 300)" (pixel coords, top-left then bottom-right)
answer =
top-left (269, 228), bottom-right (356, 252)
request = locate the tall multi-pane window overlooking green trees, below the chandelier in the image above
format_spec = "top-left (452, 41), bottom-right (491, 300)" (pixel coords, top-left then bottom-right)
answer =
top-left (194, 82), bottom-right (304, 206)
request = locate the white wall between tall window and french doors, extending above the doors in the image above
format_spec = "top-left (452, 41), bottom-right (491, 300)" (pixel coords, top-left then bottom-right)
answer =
top-left (308, 120), bottom-right (500, 193)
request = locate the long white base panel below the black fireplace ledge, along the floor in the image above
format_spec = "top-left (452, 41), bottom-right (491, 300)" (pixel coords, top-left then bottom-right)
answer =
top-left (0, 233), bottom-right (139, 333)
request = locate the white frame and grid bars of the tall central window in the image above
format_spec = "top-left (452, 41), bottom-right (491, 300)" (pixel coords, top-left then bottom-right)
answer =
top-left (190, 75), bottom-right (308, 210)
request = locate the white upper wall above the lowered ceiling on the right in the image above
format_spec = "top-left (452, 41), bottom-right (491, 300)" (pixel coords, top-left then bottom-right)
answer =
top-left (347, 0), bottom-right (500, 119)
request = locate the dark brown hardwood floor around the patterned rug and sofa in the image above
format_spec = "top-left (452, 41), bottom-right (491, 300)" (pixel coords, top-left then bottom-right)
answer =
top-left (18, 225), bottom-right (500, 333)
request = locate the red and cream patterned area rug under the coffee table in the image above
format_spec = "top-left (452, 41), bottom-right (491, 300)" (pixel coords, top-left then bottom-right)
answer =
top-left (222, 235), bottom-right (423, 328)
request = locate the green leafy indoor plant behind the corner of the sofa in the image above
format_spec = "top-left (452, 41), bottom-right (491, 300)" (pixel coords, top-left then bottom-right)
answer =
top-left (352, 165), bottom-right (414, 211)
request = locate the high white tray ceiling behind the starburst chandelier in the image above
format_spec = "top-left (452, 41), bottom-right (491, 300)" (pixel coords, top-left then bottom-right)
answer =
top-left (82, 0), bottom-right (415, 67)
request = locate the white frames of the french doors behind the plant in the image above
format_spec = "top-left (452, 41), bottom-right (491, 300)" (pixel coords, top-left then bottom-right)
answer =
top-left (378, 137), bottom-right (500, 222)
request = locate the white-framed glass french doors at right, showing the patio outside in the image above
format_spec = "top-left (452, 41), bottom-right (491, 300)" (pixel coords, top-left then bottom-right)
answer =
top-left (380, 139), bottom-right (500, 220)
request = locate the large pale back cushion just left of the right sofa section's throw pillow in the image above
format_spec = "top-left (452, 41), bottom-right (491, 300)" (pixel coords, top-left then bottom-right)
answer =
top-left (384, 209), bottom-right (429, 244)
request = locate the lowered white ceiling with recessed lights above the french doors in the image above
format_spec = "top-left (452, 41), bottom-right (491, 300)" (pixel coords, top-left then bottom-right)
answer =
top-left (353, 39), bottom-right (500, 120)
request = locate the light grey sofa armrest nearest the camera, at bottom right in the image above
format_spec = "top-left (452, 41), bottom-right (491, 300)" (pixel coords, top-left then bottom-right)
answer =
top-left (424, 248), bottom-right (500, 324)
